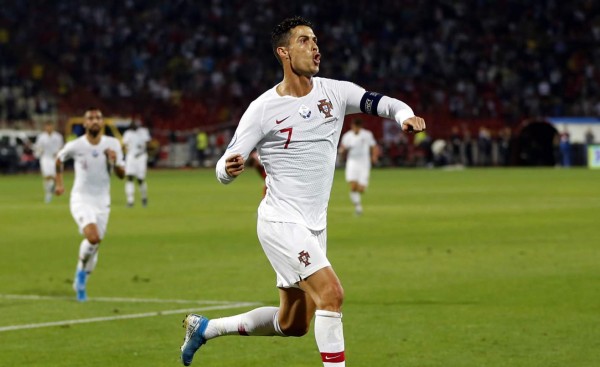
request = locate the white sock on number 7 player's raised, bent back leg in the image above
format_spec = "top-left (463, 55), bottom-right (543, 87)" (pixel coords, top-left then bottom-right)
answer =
top-left (204, 307), bottom-right (285, 340)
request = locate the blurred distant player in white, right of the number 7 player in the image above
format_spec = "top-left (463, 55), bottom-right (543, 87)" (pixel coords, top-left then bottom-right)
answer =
top-left (340, 118), bottom-right (378, 215)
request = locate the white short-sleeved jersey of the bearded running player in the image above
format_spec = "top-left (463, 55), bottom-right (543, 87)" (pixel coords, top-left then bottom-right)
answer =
top-left (58, 135), bottom-right (124, 206)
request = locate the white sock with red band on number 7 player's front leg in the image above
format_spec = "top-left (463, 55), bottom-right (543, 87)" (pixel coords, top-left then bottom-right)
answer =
top-left (315, 310), bottom-right (346, 367)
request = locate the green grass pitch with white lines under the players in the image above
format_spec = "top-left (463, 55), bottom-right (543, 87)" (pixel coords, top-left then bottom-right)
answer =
top-left (0, 168), bottom-right (600, 367)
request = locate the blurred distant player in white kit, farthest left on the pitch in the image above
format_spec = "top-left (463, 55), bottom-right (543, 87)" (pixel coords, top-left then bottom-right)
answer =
top-left (34, 122), bottom-right (64, 203)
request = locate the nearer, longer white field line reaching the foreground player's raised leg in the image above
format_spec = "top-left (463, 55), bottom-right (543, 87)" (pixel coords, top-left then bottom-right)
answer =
top-left (0, 302), bottom-right (257, 332)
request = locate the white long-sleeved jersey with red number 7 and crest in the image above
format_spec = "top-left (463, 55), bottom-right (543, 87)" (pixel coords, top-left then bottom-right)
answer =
top-left (216, 77), bottom-right (414, 230)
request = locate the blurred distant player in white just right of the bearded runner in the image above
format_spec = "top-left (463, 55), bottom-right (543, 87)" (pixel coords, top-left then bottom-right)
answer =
top-left (123, 121), bottom-right (150, 208)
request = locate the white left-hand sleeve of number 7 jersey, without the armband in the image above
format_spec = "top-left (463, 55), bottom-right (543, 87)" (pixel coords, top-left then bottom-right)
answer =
top-left (216, 102), bottom-right (264, 184)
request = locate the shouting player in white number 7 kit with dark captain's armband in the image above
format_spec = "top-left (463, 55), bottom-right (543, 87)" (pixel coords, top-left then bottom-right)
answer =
top-left (181, 17), bottom-right (425, 367)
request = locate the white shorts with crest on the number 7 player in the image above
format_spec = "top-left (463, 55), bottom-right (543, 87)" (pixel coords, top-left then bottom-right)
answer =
top-left (256, 219), bottom-right (331, 288)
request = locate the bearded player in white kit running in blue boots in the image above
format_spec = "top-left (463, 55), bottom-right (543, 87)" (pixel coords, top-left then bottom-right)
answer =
top-left (56, 108), bottom-right (125, 302)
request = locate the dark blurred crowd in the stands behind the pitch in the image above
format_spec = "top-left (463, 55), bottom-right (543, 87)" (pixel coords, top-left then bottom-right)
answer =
top-left (0, 0), bottom-right (600, 165)
